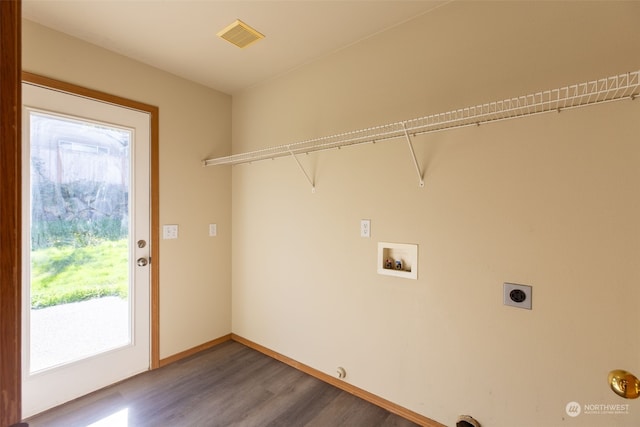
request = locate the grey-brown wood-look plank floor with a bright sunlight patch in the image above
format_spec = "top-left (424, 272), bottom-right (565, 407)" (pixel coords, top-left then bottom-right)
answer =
top-left (27, 341), bottom-right (417, 427)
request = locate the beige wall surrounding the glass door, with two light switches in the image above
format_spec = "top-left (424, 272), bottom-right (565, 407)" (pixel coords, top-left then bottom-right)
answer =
top-left (23, 21), bottom-right (231, 358)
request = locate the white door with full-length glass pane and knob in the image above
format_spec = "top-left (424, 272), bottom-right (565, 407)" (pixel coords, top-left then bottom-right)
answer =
top-left (22, 83), bottom-right (151, 418)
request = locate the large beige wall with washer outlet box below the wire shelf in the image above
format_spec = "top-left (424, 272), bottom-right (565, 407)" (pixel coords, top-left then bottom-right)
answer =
top-left (232, 2), bottom-right (640, 427)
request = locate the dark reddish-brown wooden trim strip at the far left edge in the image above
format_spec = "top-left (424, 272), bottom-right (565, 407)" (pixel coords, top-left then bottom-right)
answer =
top-left (0, 1), bottom-right (22, 426)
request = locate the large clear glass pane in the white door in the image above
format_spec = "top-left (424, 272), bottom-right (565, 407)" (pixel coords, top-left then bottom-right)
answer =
top-left (30, 111), bottom-right (132, 373)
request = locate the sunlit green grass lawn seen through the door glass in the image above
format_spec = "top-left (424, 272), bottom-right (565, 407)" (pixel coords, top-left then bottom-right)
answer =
top-left (31, 239), bottom-right (129, 308)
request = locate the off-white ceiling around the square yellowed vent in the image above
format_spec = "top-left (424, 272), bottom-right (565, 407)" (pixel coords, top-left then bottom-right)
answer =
top-left (22, 0), bottom-right (450, 94)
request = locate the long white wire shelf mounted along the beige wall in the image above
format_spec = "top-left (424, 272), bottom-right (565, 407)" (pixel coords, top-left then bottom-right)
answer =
top-left (202, 71), bottom-right (640, 166)
